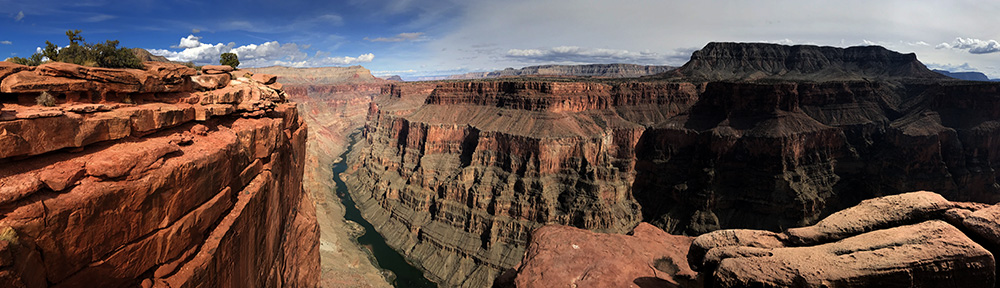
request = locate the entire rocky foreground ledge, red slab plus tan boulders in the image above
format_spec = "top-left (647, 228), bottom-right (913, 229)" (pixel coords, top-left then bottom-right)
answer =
top-left (499, 191), bottom-right (1000, 287)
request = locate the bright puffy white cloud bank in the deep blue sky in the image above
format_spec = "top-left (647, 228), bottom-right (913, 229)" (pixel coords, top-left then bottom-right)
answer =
top-left (149, 35), bottom-right (375, 67)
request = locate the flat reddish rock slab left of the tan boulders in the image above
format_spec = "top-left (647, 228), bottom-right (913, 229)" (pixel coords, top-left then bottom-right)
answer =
top-left (515, 223), bottom-right (694, 287)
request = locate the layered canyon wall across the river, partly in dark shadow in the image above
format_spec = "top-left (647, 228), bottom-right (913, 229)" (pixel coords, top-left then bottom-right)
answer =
top-left (348, 44), bottom-right (1000, 286)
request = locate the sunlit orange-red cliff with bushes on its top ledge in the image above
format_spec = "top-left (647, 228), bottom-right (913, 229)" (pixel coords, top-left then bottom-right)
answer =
top-left (0, 62), bottom-right (319, 287)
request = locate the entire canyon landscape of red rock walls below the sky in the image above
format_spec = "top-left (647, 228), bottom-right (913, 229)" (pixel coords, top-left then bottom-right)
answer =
top-left (0, 43), bottom-right (1000, 287)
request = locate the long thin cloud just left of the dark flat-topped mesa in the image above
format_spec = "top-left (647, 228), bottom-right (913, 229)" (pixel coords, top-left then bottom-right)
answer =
top-left (506, 46), bottom-right (691, 64)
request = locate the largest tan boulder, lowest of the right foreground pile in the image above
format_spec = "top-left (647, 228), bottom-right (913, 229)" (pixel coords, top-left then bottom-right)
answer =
top-left (709, 220), bottom-right (995, 287)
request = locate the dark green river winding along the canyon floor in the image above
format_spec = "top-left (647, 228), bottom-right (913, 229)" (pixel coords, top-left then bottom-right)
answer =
top-left (333, 144), bottom-right (437, 288)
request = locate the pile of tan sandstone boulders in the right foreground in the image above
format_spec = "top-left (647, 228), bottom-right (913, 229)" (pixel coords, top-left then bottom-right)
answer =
top-left (688, 192), bottom-right (998, 287)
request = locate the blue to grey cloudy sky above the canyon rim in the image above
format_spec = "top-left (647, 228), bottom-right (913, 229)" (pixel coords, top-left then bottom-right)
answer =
top-left (0, 0), bottom-right (1000, 80)
